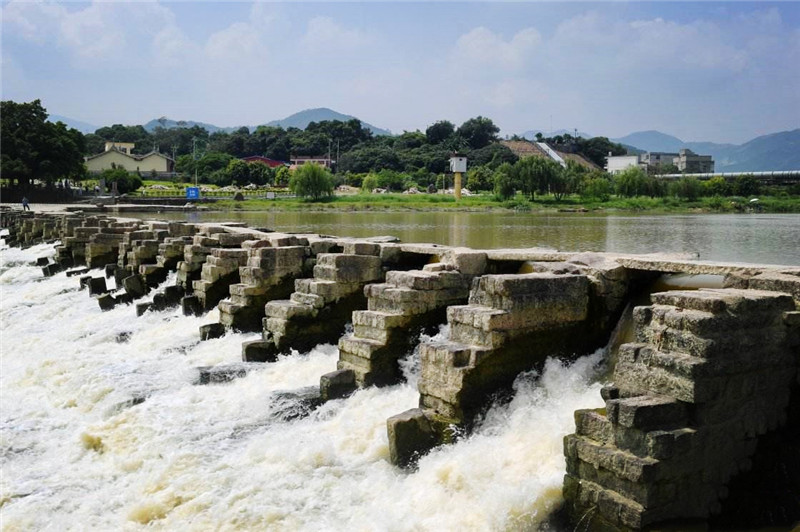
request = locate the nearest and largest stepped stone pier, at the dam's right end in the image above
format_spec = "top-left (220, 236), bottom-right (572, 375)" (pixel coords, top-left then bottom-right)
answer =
top-left (564, 286), bottom-right (800, 531)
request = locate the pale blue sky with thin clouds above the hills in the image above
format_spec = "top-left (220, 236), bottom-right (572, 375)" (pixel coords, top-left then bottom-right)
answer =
top-left (0, 1), bottom-right (800, 143)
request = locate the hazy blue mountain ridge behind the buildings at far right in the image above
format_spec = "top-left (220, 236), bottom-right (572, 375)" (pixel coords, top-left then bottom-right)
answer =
top-left (612, 129), bottom-right (800, 172)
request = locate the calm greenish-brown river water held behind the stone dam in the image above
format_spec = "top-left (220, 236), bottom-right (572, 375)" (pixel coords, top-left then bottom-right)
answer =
top-left (133, 212), bottom-right (800, 265)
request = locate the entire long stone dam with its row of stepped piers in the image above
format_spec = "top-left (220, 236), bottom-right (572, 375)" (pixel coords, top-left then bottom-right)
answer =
top-left (1, 211), bottom-right (800, 531)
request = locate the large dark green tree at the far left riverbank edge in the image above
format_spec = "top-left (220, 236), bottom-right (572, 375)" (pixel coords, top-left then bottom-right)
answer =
top-left (0, 100), bottom-right (86, 186)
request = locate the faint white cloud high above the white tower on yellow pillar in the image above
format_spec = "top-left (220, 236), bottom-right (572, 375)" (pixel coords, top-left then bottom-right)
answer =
top-left (454, 26), bottom-right (542, 70)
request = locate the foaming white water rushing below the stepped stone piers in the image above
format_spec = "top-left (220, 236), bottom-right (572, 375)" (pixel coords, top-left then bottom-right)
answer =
top-left (0, 240), bottom-right (602, 531)
